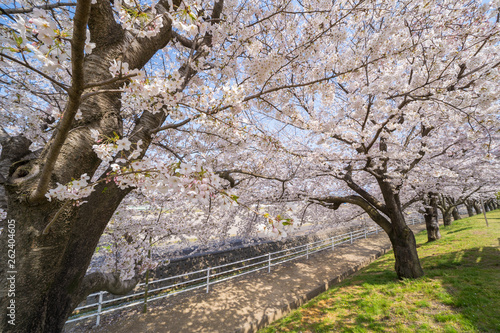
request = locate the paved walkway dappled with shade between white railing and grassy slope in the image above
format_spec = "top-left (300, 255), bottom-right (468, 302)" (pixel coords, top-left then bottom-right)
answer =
top-left (68, 224), bottom-right (425, 333)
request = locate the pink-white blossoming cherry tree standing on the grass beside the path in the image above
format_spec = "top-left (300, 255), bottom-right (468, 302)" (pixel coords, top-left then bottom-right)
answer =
top-left (229, 1), bottom-right (499, 278)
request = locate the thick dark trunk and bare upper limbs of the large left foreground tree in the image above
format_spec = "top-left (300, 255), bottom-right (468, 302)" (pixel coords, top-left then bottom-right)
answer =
top-left (0, 0), bottom-right (223, 333)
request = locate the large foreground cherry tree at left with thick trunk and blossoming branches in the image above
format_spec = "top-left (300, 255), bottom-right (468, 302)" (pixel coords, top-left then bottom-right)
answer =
top-left (0, 0), bottom-right (374, 332)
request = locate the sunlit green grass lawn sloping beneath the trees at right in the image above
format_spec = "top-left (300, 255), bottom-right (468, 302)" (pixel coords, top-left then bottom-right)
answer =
top-left (259, 210), bottom-right (500, 333)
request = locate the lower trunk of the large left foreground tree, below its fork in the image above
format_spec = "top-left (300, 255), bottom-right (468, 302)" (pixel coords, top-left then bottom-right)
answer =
top-left (2, 184), bottom-right (129, 332)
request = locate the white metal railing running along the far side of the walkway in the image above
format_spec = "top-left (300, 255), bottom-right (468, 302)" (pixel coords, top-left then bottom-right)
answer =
top-left (66, 214), bottom-right (423, 325)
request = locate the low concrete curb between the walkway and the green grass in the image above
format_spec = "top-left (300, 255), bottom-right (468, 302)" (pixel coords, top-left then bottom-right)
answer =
top-left (234, 241), bottom-right (392, 333)
